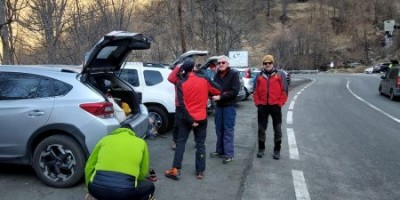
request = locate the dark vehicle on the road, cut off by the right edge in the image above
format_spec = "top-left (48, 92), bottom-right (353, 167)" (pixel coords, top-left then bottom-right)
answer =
top-left (379, 65), bottom-right (400, 100)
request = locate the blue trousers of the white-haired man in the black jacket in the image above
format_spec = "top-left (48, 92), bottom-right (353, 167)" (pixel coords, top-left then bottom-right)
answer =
top-left (214, 106), bottom-right (236, 158)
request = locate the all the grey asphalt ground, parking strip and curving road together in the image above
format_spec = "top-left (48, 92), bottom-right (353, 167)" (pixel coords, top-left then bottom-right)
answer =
top-left (0, 74), bottom-right (400, 200)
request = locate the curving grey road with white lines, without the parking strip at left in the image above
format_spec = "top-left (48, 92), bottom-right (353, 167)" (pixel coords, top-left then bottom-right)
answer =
top-left (242, 74), bottom-right (400, 200)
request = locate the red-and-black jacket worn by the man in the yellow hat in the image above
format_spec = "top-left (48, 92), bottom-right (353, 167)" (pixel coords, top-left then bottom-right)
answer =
top-left (253, 69), bottom-right (288, 107)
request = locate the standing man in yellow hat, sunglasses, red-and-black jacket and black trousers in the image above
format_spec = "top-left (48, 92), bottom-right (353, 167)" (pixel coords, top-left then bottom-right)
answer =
top-left (253, 55), bottom-right (288, 160)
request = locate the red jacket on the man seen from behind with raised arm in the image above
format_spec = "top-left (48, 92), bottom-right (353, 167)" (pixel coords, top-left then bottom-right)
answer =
top-left (177, 72), bottom-right (221, 124)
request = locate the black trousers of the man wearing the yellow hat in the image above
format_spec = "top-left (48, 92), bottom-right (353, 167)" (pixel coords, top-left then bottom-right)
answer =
top-left (257, 105), bottom-right (282, 151)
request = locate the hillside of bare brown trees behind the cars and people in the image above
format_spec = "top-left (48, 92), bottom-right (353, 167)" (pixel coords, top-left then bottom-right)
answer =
top-left (0, 0), bottom-right (400, 69)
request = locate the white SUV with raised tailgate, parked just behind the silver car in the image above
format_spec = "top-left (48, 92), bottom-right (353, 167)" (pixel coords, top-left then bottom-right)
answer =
top-left (116, 50), bottom-right (208, 134)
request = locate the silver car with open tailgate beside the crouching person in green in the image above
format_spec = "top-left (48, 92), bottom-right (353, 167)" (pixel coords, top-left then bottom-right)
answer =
top-left (0, 32), bottom-right (151, 188)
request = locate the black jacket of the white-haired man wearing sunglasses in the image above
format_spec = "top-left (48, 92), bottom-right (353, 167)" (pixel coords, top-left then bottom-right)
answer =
top-left (214, 68), bottom-right (240, 107)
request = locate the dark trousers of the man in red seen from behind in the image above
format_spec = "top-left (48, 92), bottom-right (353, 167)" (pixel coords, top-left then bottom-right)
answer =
top-left (172, 120), bottom-right (207, 173)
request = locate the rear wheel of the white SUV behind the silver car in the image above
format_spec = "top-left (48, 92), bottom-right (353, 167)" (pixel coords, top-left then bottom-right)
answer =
top-left (147, 106), bottom-right (169, 134)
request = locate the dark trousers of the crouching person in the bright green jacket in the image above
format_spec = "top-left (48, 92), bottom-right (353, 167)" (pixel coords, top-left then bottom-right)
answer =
top-left (88, 172), bottom-right (155, 200)
